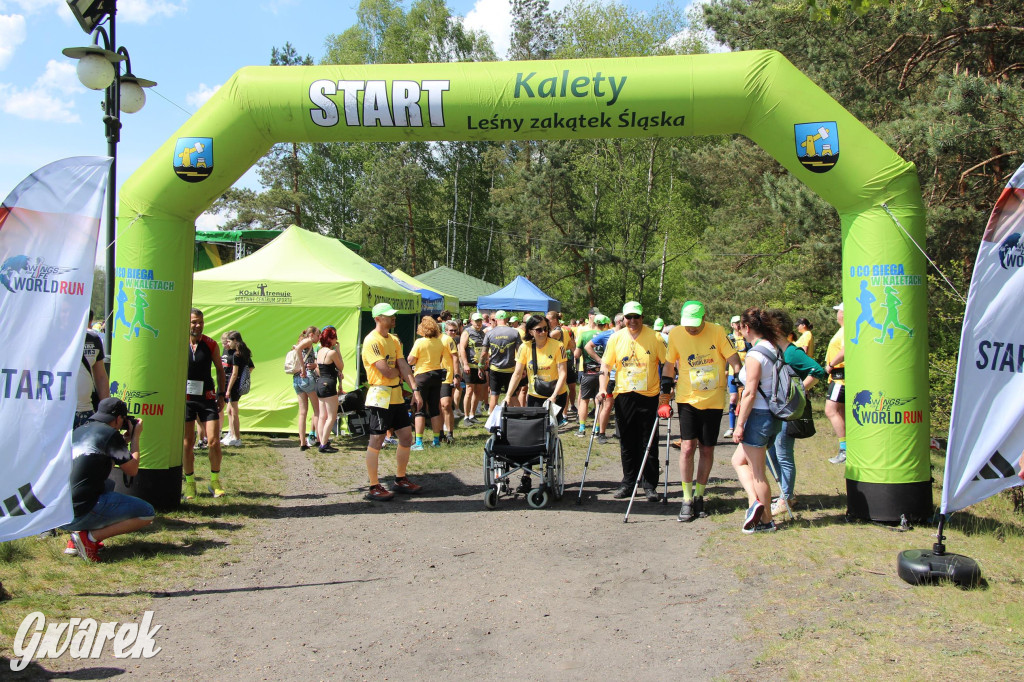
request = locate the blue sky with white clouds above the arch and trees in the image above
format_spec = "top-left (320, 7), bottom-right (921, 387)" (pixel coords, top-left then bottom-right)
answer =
top-left (0, 0), bottom-right (689, 228)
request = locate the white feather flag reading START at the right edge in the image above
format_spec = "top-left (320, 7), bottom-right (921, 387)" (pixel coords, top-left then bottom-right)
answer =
top-left (942, 160), bottom-right (1024, 513)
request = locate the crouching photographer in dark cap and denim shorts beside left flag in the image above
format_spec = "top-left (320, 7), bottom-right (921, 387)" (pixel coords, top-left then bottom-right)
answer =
top-left (61, 397), bottom-right (155, 561)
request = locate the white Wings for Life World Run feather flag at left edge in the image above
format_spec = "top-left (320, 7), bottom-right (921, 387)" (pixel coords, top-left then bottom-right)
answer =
top-left (0, 157), bottom-right (111, 542)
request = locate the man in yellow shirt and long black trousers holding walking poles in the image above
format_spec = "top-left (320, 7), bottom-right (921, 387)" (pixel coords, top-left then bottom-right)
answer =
top-left (597, 301), bottom-right (666, 502)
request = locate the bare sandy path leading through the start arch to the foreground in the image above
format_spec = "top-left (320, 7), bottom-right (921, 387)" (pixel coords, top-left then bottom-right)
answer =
top-left (56, 428), bottom-right (756, 680)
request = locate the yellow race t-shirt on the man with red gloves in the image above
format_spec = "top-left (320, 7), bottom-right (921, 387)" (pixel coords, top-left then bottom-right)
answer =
top-left (667, 322), bottom-right (736, 410)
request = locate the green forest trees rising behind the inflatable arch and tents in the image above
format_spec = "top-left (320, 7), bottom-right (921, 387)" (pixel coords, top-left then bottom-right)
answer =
top-left (205, 0), bottom-right (1024, 433)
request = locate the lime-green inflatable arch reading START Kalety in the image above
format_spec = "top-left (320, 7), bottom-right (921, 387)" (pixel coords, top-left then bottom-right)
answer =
top-left (112, 51), bottom-right (932, 521)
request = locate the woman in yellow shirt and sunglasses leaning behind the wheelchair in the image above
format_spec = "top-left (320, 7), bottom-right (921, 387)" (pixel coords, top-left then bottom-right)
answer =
top-left (506, 315), bottom-right (568, 415)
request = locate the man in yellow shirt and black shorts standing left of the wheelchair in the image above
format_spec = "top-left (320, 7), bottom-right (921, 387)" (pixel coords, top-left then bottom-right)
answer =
top-left (361, 303), bottom-right (423, 501)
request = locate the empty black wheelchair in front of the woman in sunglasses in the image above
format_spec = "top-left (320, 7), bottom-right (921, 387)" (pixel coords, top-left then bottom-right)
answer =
top-left (483, 407), bottom-right (565, 509)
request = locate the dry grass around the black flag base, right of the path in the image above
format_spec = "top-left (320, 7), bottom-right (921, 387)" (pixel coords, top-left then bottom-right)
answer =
top-left (706, 413), bottom-right (1024, 679)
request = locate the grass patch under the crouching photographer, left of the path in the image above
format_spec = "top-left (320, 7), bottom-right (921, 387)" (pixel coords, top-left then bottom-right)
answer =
top-left (0, 436), bottom-right (285, 656)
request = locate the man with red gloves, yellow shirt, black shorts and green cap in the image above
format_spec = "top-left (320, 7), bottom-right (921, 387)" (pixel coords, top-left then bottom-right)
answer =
top-left (662, 301), bottom-right (741, 521)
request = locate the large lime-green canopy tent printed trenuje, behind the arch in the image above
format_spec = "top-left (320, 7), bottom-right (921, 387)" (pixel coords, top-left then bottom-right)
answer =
top-left (193, 225), bottom-right (420, 433)
